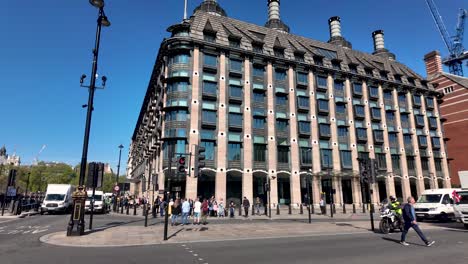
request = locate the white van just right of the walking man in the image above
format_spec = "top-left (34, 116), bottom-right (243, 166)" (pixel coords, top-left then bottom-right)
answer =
top-left (414, 189), bottom-right (460, 222)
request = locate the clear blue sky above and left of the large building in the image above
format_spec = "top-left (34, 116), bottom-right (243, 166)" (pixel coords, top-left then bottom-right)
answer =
top-left (0, 0), bottom-right (468, 172)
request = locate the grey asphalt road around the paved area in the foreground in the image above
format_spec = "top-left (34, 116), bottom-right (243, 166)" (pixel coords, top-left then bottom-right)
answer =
top-left (0, 215), bottom-right (468, 264)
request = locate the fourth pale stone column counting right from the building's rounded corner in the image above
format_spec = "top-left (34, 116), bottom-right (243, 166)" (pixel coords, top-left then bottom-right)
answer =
top-left (267, 62), bottom-right (278, 206)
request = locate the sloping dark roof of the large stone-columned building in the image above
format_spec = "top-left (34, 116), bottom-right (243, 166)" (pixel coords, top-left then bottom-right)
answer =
top-left (190, 10), bottom-right (432, 88)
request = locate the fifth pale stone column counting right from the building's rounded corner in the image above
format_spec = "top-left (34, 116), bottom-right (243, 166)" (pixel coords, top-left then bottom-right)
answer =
top-left (288, 67), bottom-right (301, 206)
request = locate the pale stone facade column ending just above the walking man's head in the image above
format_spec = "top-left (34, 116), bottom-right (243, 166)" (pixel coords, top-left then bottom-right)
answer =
top-left (391, 89), bottom-right (411, 197)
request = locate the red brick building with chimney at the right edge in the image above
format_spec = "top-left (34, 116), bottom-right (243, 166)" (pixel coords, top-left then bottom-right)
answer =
top-left (424, 51), bottom-right (468, 186)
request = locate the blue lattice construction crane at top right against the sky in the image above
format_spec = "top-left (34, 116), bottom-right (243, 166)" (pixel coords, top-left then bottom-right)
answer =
top-left (426, 0), bottom-right (468, 76)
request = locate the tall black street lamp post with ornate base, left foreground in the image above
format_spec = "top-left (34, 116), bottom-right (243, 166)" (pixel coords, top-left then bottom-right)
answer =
top-left (67, 0), bottom-right (110, 236)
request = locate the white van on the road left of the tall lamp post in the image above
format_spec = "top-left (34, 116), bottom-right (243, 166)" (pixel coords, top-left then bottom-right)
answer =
top-left (41, 184), bottom-right (75, 214)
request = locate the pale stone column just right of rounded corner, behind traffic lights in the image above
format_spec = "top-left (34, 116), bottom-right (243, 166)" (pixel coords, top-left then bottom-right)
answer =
top-left (185, 47), bottom-right (201, 198)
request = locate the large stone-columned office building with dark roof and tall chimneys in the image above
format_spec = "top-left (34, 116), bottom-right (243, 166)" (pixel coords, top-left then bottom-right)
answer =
top-left (127, 0), bottom-right (450, 206)
